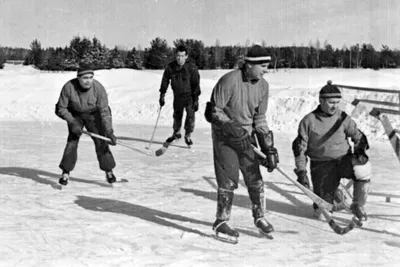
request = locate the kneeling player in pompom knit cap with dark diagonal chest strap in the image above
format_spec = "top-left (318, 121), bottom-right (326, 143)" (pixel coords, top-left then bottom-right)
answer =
top-left (292, 81), bottom-right (372, 224)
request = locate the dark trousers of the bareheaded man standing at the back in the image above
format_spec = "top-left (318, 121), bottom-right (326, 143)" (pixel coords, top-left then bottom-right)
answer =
top-left (173, 95), bottom-right (195, 134)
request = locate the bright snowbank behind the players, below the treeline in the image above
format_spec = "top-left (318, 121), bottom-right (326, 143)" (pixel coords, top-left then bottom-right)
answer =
top-left (0, 64), bottom-right (400, 138)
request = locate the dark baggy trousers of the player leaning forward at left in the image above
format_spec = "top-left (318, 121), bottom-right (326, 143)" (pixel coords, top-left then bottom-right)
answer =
top-left (59, 112), bottom-right (115, 172)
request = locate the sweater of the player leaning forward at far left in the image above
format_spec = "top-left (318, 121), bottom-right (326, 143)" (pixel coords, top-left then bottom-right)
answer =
top-left (55, 78), bottom-right (112, 130)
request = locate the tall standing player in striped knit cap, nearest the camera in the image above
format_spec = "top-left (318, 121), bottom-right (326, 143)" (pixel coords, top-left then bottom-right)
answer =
top-left (205, 45), bottom-right (278, 243)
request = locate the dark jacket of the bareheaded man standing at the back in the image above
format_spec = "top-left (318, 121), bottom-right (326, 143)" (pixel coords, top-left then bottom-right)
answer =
top-left (160, 60), bottom-right (201, 101)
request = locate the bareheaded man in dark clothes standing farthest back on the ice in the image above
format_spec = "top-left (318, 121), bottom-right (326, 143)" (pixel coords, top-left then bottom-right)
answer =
top-left (159, 45), bottom-right (201, 146)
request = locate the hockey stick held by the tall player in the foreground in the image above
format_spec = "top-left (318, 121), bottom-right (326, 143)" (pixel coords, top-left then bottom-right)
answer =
top-left (253, 146), bottom-right (356, 235)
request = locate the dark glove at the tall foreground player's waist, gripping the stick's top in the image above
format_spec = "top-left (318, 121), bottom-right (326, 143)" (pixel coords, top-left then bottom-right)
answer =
top-left (221, 122), bottom-right (251, 153)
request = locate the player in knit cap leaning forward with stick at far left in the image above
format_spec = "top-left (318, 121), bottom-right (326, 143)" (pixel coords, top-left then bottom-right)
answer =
top-left (55, 66), bottom-right (116, 185)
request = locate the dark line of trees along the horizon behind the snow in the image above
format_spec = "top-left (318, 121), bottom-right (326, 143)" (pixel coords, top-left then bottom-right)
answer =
top-left (0, 36), bottom-right (400, 71)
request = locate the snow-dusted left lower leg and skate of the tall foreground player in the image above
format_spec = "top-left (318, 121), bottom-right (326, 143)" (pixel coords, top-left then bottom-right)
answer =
top-left (212, 189), bottom-right (239, 244)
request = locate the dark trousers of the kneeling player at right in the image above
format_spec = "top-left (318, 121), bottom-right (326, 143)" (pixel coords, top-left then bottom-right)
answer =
top-left (310, 155), bottom-right (354, 203)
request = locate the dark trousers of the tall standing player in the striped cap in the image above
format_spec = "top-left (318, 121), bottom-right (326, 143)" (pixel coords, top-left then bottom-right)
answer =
top-left (212, 131), bottom-right (264, 220)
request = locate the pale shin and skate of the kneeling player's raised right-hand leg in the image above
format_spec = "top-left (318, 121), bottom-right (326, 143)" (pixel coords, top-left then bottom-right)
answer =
top-left (350, 180), bottom-right (370, 224)
